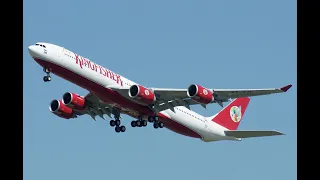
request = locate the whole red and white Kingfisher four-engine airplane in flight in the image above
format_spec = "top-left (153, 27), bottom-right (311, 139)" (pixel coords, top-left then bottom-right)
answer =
top-left (28, 42), bottom-right (292, 142)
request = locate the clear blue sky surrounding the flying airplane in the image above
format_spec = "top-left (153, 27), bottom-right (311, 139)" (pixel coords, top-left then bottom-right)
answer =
top-left (23, 0), bottom-right (297, 180)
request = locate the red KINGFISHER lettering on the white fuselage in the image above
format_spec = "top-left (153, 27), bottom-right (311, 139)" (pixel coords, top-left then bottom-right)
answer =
top-left (74, 53), bottom-right (123, 86)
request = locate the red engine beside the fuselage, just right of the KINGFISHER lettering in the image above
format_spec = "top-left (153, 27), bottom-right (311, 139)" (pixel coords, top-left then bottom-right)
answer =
top-left (128, 84), bottom-right (156, 105)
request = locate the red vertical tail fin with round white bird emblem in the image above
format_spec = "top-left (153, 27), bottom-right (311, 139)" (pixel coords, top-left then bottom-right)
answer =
top-left (212, 97), bottom-right (250, 130)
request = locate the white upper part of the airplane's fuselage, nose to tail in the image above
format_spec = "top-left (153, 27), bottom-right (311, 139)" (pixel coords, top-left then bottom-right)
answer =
top-left (29, 43), bottom-right (237, 141)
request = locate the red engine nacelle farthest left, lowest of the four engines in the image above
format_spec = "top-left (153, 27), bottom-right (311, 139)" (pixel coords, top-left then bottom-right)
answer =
top-left (49, 100), bottom-right (73, 119)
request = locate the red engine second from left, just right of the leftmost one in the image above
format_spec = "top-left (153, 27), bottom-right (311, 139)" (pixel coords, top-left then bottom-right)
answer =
top-left (62, 92), bottom-right (86, 110)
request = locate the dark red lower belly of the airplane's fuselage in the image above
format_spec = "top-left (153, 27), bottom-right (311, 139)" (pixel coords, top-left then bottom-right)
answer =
top-left (34, 58), bottom-right (201, 138)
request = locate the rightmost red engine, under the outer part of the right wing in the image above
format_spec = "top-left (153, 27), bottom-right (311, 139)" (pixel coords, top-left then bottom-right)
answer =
top-left (187, 84), bottom-right (214, 104)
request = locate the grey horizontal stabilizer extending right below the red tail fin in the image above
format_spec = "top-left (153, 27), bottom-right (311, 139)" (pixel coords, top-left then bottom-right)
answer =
top-left (224, 130), bottom-right (284, 138)
